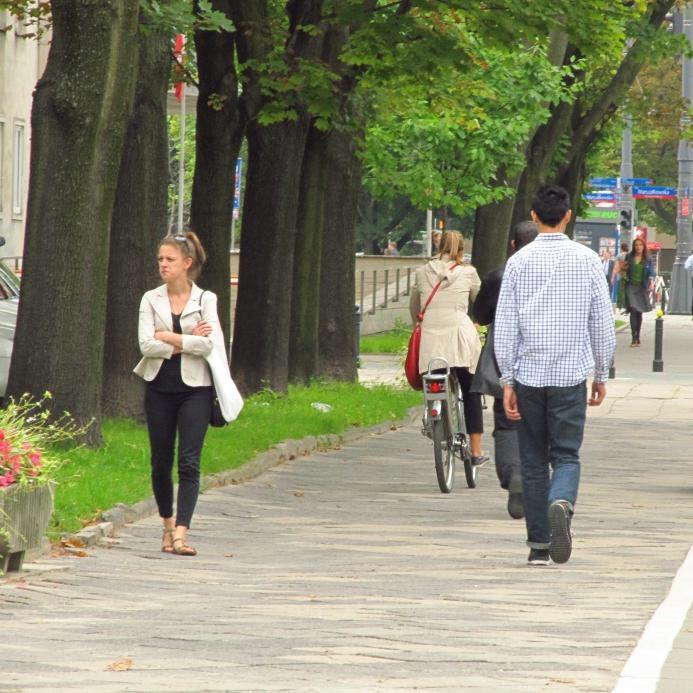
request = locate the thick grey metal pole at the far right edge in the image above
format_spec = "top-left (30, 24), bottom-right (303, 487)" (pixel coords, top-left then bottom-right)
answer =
top-left (669, 4), bottom-right (693, 315)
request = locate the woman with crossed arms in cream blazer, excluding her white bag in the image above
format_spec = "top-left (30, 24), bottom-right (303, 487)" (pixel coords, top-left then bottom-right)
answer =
top-left (135, 231), bottom-right (223, 556)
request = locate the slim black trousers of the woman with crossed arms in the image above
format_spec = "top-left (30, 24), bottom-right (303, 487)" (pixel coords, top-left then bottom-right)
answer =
top-left (144, 387), bottom-right (212, 527)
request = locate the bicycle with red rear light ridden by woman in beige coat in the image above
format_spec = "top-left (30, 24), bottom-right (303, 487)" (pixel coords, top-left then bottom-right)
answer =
top-left (421, 357), bottom-right (477, 493)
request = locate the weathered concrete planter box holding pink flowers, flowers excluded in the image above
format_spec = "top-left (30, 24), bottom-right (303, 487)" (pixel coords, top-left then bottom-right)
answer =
top-left (0, 483), bottom-right (54, 575)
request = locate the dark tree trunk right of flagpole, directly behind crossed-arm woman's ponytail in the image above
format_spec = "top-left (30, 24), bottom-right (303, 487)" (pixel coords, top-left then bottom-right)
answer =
top-left (190, 0), bottom-right (245, 339)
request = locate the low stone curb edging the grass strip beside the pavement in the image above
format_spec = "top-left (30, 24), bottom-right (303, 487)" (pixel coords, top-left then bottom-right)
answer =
top-left (61, 406), bottom-right (421, 547)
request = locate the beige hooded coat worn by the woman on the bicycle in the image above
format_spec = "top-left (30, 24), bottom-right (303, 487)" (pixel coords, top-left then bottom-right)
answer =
top-left (409, 258), bottom-right (481, 373)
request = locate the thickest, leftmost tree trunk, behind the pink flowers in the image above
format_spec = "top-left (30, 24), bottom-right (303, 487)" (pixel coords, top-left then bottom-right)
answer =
top-left (8, 0), bottom-right (138, 443)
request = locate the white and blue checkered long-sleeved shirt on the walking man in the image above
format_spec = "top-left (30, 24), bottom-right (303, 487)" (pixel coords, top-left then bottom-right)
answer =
top-left (494, 233), bottom-right (616, 387)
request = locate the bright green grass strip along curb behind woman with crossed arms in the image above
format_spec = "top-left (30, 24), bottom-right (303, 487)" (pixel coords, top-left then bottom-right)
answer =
top-left (51, 383), bottom-right (421, 536)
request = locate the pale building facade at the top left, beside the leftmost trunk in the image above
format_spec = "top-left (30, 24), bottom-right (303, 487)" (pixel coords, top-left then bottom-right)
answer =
top-left (0, 11), bottom-right (50, 258)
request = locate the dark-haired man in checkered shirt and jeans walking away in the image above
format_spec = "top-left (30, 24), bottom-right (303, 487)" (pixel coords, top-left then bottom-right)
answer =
top-left (495, 185), bottom-right (616, 565)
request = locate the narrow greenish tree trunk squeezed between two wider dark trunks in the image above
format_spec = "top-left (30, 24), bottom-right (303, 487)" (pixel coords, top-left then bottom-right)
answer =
top-left (289, 125), bottom-right (327, 384)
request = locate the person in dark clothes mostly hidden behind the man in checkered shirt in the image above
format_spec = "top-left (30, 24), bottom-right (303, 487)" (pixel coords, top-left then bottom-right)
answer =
top-left (472, 221), bottom-right (537, 520)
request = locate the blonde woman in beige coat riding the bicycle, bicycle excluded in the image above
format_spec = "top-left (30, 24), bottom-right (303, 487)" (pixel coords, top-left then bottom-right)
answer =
top-left (409, 231), bottom-right (489, 466)
